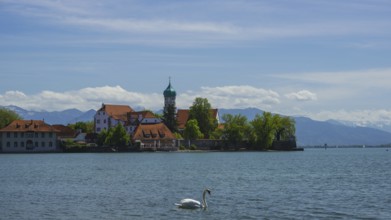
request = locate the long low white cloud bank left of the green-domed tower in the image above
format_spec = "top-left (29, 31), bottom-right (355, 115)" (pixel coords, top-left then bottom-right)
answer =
top-left (0, 86), bottom-right (163, 111)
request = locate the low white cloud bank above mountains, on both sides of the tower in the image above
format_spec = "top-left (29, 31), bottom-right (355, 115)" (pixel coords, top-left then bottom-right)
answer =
top-left (0, 86), bottom-right (280, 111)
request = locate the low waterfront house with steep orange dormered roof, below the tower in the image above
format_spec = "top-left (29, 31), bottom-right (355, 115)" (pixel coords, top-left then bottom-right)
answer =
top-left (133, 123), bottom-right (177, 151)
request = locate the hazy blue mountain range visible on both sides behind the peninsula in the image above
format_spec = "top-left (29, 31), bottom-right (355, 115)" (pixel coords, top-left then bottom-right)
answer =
top-left (4, 106), bottom-right (391, 147)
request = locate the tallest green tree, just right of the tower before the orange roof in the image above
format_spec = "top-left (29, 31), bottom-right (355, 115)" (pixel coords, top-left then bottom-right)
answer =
top-left (189, 97), bottom-right (217, 138)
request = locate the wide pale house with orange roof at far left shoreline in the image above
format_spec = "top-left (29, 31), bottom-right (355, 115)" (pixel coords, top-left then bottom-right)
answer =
top-left (0, 120), bottom-right (59, 152)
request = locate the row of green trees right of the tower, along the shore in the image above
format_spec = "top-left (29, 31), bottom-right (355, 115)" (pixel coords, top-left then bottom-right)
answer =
top-left (163, 97), bottom-right (296, 149)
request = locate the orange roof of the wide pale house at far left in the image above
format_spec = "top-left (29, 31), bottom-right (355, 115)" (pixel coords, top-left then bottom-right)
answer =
top-left (0, 120), bottom-right (59, 132)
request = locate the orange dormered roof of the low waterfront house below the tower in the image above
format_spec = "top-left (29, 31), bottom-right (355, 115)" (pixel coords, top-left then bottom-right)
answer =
top-left (133, 123), bottom-right (175, 140)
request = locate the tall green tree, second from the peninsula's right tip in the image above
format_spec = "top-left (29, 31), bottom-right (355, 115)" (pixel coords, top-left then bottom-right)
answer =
top-left (250, 112), bottom-right (275, 149)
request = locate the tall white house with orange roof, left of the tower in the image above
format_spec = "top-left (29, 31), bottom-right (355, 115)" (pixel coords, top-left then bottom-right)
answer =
top-left (94, 104), bottom-right (134, 133)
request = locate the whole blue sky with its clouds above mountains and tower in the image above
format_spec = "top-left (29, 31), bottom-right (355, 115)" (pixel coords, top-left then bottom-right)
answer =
top-left (0, 0), bottom-right (391, 124)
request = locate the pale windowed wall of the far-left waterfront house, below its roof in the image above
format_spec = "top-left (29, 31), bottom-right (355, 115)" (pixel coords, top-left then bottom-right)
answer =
top-left (0, 132), bottom-right (58, 152)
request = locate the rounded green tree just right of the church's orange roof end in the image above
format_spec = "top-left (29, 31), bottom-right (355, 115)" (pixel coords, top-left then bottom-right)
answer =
top-left (223, 114), bottom-right (250, 147)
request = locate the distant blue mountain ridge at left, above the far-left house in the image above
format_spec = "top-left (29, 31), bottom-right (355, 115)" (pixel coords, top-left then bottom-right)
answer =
top-left (4, 105), bottom-right (95, 125)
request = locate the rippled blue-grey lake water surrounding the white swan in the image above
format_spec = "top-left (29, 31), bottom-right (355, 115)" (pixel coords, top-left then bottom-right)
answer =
top-left (0, 148), bottom-right (391, 219)
